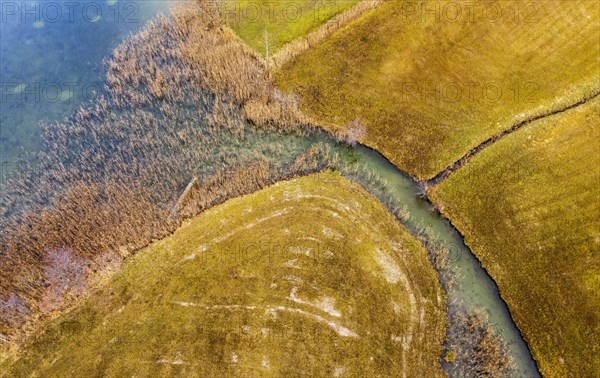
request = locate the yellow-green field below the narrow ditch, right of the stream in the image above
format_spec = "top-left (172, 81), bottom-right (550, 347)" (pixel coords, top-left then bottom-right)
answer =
top-left (432, 99), bottom-right (600, 377)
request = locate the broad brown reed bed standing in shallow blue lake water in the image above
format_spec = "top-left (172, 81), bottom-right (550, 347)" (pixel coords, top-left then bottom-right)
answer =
top-left (0, 3), bottom-right (324, 341)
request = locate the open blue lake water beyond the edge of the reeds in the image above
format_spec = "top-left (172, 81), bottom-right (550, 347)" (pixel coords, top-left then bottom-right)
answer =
top-left (0, 0), bottom-right (173, 173)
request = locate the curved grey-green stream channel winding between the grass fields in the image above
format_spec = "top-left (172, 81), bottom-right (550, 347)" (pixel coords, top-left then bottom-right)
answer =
top-left (232, 131), bottom-right (540, 377)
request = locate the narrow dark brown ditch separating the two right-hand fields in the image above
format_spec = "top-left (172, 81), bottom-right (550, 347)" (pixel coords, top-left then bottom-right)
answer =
top-left (422, 90), bottom-right (600, 188)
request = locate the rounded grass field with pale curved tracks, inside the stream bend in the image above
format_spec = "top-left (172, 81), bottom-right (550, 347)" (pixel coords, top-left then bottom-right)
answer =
top-left (0, 173), bottom-right (446, 377)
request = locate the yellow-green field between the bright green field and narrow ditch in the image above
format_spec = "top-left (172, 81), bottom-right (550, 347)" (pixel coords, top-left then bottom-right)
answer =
top-left (277, 0), bottom-right (600, 179)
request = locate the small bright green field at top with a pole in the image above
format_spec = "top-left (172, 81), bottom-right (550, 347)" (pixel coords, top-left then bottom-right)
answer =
top-left (220, 0), bottom-right (359, 55)
